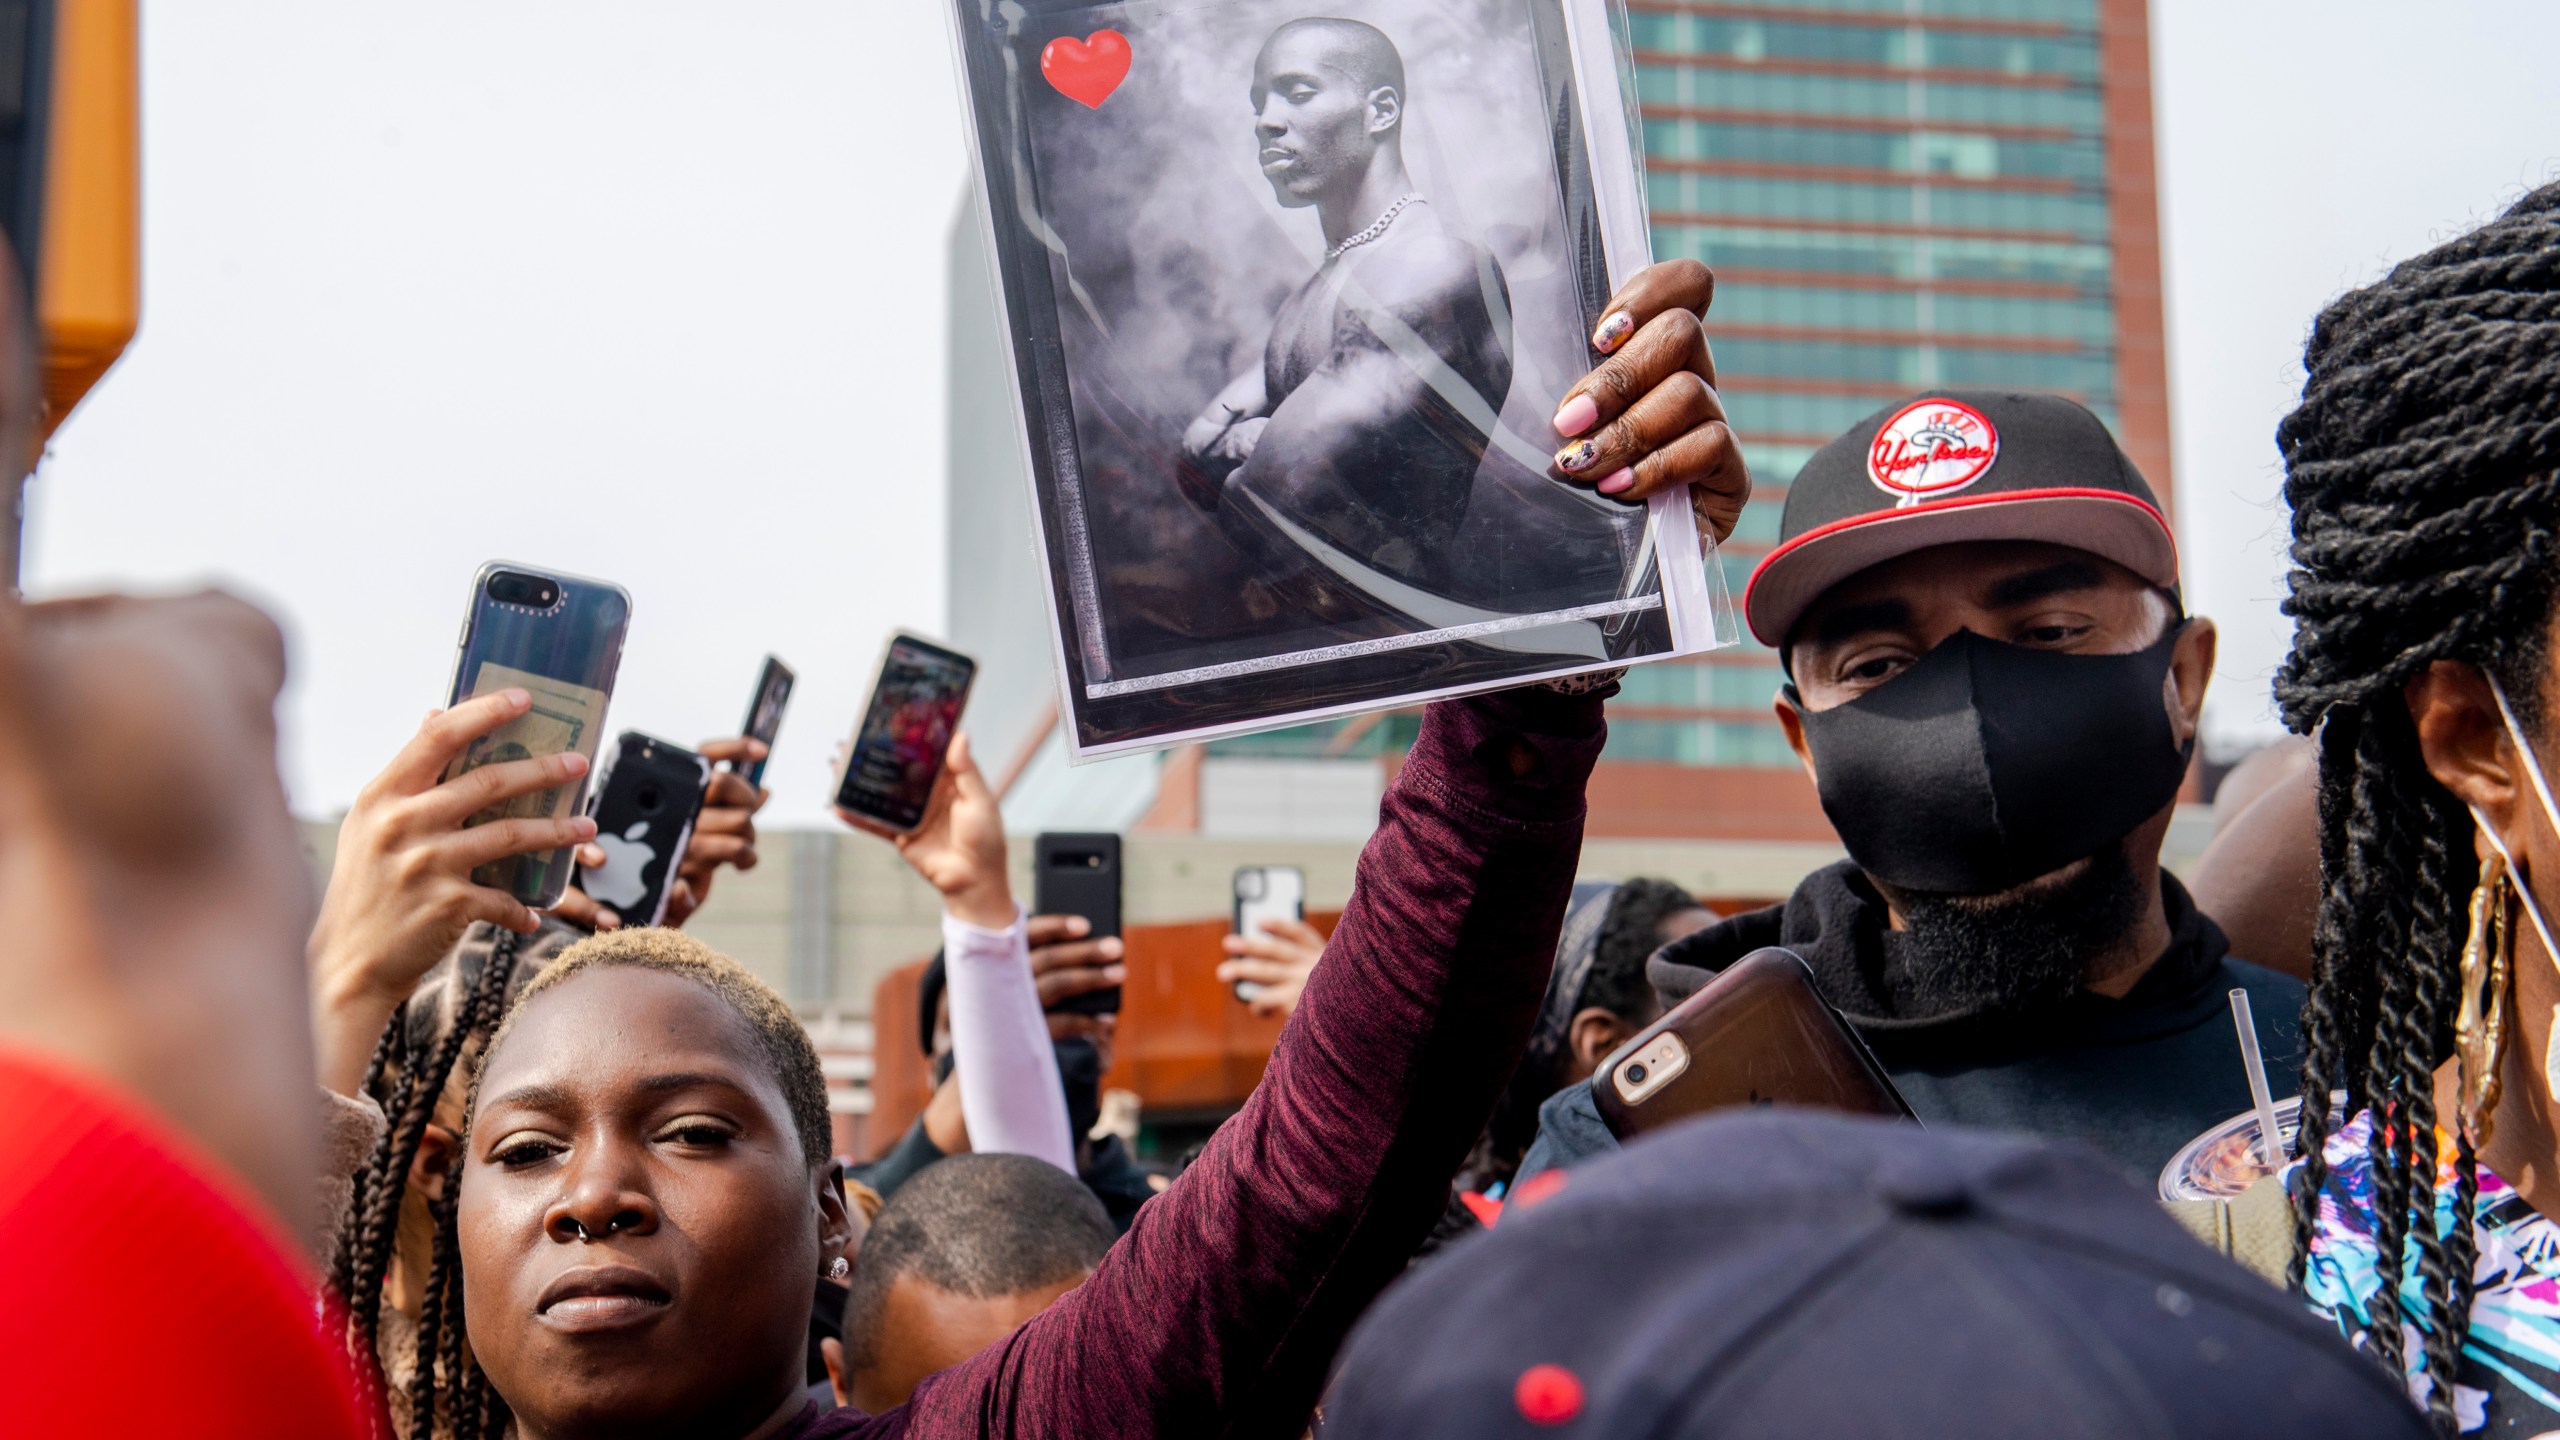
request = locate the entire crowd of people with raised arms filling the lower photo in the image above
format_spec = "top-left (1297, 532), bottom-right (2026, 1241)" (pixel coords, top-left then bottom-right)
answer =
top-left (0, 187), bottom-right (2560, 1440)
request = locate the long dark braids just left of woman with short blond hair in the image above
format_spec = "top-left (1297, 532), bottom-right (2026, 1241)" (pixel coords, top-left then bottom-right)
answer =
top-left (330, 933), bottom-right (522, 1440)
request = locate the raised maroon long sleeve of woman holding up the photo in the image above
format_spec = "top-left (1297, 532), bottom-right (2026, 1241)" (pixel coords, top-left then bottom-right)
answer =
top-left (783, 689), bottom-right (1603, 1440)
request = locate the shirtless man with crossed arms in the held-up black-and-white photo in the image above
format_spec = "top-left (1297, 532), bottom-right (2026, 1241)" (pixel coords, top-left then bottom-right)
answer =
top-left (1178, 18), bottom-right (1510, 589)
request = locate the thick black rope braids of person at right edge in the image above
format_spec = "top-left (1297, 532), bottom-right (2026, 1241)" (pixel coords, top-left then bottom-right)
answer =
top-left (2276, 184), bottom-right (2560, 1435)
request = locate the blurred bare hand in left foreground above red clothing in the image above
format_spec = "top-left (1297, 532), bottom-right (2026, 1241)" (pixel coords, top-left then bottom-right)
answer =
top-left (0, 594), bottom-right (320, 1235)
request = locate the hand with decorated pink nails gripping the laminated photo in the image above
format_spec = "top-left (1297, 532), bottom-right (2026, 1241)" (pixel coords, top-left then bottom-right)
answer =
top-left (1554, 259), bottom-right (1751, 541)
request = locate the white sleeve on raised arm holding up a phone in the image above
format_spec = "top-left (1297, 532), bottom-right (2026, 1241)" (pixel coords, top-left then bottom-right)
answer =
top-left (942, 912), bottom-right (1075, 1174)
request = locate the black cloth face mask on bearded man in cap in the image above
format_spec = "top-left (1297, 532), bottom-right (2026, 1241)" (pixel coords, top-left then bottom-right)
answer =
top-left (1787, 625), bottom-right (2194, 894)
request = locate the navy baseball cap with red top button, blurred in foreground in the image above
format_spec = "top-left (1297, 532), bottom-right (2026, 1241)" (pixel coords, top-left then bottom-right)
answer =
top-left (1324, 1109), bottom-right (2427, 1440)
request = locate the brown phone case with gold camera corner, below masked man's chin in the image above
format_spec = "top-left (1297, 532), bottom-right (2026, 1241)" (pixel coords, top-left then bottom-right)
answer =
top-left (1592, 945), bottom-right (1915, 1140)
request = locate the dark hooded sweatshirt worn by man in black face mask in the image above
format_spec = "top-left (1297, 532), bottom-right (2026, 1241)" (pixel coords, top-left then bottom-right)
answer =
top-left (1513, 861), bottom-right (2301, 1189)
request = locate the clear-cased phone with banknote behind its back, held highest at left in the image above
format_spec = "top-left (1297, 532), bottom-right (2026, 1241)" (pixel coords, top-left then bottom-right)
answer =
top-left (445, 561), bottom-right (632, 910)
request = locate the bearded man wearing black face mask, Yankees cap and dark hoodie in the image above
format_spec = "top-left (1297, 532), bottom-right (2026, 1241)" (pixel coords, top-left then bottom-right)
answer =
top-left (1521, 389), bottom-right (2301, 1186)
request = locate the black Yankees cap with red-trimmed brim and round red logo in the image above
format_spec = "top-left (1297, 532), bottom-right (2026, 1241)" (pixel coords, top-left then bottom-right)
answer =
top-left (1743, 389), bottom-right (2179, 646)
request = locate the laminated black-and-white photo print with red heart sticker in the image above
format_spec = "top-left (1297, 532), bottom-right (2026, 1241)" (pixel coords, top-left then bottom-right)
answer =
top-left (945, 0), bottom-right (1736, 758)
